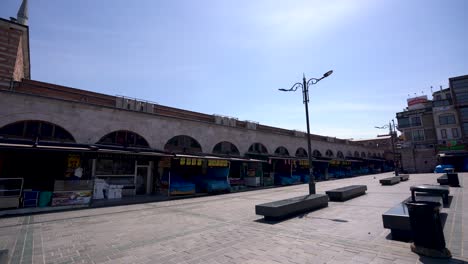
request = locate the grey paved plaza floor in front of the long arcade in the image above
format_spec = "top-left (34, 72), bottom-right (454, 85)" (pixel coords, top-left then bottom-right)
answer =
top-left (0, 173), bottom-right (468, 264)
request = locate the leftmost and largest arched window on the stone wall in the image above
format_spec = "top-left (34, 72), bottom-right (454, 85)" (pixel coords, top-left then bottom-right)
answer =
top-left (0, 120), bottom-right (75, 142)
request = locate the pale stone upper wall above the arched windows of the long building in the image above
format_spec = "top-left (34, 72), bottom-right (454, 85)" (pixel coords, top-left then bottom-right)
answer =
top-left (0, 81), bottom-right (383, 157)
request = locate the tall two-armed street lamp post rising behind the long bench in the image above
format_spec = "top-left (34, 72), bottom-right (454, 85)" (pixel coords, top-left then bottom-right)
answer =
top-left (278, 71), bottom-right (333, 194)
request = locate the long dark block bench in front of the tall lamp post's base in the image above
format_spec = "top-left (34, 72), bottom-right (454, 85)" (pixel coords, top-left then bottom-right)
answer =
top-left (255, 194), bottom-right (328, 220)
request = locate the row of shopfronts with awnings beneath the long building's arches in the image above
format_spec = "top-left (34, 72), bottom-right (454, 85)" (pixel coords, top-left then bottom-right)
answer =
top-left (0, 121), bottom-right (391, 214)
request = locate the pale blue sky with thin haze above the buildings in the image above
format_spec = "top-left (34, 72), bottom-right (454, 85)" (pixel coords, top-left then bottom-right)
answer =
top-left (0, 0), bottom-right (468, 139)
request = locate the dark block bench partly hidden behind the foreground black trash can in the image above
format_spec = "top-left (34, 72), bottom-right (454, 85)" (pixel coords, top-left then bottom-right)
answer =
top-left (382, 195), bottom-right (442, 240)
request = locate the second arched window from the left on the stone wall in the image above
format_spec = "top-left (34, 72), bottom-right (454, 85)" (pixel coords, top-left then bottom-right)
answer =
top-left (97, 130), bottom-right (149, 148)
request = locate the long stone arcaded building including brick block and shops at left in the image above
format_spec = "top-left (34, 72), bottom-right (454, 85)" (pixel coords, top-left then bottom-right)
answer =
top-left (0, 2), bottom-right (384, 211)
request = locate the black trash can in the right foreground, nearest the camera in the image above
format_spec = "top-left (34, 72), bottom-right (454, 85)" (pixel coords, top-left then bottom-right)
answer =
top-left (406, 201), bottom-right (445, 250)
